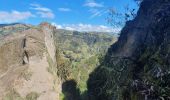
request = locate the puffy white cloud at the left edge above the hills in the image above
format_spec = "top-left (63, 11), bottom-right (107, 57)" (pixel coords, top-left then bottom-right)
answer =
top-left (0, 10), bottom-right (35, 23)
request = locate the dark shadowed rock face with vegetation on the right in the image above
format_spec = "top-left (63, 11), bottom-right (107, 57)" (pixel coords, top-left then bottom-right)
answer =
top-left (88, 0), bottom-right (170, 100)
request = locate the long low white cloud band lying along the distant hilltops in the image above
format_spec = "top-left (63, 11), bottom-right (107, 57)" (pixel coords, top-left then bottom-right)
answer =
top-left (52, 23), bottom-right (121, 33)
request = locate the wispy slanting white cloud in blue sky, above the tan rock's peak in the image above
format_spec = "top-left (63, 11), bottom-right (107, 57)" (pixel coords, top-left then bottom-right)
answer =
top-left (30, 4), bottom-right (55, 19)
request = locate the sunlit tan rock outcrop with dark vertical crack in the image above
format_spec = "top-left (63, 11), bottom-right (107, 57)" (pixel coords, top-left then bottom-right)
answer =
top-left (0, 23), bottom-right (60, 100)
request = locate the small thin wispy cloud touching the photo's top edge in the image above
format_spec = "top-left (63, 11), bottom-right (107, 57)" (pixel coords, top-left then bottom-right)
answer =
top-left (84, 0), bottom-right (104, 8)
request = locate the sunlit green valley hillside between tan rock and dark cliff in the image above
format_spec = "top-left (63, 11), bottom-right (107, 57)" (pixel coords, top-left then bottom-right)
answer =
top-left (55, 30), bottom-right (116, 92)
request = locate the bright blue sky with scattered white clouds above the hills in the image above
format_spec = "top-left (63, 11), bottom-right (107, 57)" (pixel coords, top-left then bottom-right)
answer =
top-left (0, 0), bottom-right (137, 32)
